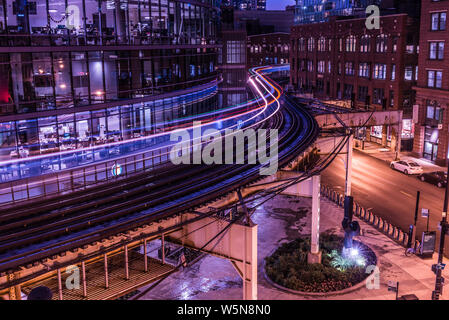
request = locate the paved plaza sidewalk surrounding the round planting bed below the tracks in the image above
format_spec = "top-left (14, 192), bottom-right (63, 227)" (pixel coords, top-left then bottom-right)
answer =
top-left (137, 195), bottom-right (449, 300)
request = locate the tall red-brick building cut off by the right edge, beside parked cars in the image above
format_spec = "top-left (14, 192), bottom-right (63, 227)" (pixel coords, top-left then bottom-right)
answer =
top-left (413, 0), bottom-right (449, 165)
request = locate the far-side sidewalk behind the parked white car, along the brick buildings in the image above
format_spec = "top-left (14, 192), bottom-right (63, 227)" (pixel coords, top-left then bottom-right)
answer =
top-left (354, 142), bottom-right (447, 172)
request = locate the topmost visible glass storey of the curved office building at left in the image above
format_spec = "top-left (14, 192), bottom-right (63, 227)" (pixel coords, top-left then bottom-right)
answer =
top-left (0, 0), bottom-right (219, 46)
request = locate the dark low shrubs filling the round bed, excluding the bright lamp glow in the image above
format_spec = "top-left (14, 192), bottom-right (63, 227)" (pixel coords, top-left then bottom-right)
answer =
top-left (265, 233), bottom-right (376, 292)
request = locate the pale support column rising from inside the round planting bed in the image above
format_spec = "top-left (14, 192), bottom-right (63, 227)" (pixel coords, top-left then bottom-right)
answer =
top-left (307, 175), bottom-right (321, 264)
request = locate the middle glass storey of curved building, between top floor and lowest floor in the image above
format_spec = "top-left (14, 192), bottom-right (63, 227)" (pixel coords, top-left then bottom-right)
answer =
top-left (0, 47), bottom-right (217, 115)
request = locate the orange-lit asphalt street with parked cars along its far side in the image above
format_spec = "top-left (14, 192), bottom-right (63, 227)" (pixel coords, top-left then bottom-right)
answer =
top-left (322, 150), bottom-right (449, 252)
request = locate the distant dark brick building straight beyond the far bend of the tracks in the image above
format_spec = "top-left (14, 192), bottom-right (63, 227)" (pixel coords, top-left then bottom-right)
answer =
top-left (247, 32), bottom-right (290, 68)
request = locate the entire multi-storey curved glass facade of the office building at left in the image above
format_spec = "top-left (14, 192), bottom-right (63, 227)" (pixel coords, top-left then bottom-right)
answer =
top-left (0, 0), bottom-right (219, 160)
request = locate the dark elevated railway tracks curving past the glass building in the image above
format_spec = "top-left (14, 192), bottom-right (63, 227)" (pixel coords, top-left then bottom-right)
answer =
top-left (0, 66), bottom-right (318, 272)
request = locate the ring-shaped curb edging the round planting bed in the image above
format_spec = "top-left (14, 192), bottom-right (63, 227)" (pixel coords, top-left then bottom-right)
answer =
top-left (262, 240), bottom-right (379, 298)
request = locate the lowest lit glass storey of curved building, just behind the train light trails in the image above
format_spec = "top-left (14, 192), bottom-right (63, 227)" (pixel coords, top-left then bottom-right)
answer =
top-left (0, 86), bottom-right (218, 161)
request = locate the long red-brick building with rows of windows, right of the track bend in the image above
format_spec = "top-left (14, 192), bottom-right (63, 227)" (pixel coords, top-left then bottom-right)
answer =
top-left (290, 14), bottom-right (419, 149)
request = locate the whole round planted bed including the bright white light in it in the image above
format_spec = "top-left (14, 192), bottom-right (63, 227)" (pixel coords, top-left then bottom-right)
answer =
top-left (264, 233), bottom-right (377, 296)
